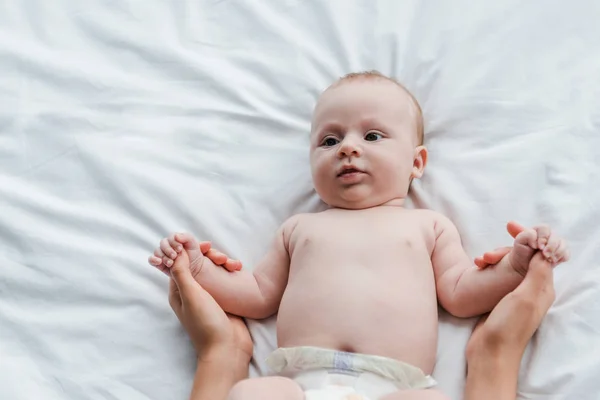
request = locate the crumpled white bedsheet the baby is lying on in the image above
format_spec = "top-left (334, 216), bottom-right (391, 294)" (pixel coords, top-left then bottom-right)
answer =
top-left (0, 0), bottom-right (600, 400)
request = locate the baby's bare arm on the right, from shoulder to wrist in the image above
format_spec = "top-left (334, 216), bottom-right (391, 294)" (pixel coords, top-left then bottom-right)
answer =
top-left (431, 215), bottom-right (523, 318)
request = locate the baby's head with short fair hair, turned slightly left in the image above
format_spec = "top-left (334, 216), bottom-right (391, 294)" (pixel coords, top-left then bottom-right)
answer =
top-left (310, 72), bottom-right (427, 209)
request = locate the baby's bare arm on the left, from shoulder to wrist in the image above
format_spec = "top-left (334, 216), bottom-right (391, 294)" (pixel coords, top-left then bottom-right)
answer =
top-left (184, 216), bottom-right (298, 319)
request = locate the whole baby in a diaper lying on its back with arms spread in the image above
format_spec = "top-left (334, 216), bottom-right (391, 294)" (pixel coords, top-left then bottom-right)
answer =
top-left (149, 72), bottom-right (568, 400)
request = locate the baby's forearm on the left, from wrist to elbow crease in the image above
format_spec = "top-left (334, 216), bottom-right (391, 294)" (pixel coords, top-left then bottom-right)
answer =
top-left (198, 264), bottom-right (274, 319)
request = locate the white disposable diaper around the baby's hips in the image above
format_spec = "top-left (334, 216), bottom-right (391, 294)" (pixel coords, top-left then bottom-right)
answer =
top-left (267, 347), bottom-right (437, 400)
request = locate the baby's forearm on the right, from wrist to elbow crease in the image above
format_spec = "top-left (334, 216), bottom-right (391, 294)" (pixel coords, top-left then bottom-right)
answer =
top-left (444, 257), bottom-right (523, 318)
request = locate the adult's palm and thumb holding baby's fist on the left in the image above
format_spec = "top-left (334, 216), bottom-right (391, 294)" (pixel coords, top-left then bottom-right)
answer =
top-left (169, 251), bottom-right (252, 371)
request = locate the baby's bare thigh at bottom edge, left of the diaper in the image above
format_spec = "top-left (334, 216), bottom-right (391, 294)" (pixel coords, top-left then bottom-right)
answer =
top-left (227, 376), bottom-right (304, 400)
